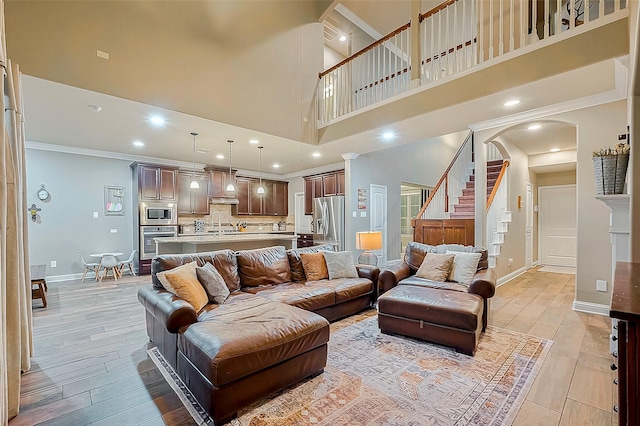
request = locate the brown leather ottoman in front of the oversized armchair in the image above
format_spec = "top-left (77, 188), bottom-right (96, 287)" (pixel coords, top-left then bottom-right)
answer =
top-left (378, 285), bottom-right (484, 355)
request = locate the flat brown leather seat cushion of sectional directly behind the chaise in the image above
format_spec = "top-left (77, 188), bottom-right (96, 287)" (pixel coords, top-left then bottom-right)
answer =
top-left (244, 282), bottom-right (336, 311)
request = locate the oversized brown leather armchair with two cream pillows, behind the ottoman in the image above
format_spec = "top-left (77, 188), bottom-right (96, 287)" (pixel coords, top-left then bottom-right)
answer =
top-left (378, 242), bottom-right (496, 331)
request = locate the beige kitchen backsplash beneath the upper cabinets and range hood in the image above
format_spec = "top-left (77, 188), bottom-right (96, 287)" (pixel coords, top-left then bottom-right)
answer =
top-left (178, 204), bottom-right (295, 234)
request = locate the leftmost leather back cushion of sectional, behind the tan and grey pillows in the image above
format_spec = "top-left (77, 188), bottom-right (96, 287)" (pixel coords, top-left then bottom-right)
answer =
top-left (151, 250), bottom-right (240, 291)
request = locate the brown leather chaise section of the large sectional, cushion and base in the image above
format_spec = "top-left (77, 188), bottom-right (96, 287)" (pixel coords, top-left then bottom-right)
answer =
top-left (177, 297), bottom-right (329, 424)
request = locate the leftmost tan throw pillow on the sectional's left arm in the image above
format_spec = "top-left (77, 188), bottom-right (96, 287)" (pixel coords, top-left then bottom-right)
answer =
top-left (156, 261), bottom-right (209, 312)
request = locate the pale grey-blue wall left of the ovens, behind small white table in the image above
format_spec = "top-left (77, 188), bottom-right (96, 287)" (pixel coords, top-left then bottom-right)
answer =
top-left (26, 148), bottom-right (137, 280)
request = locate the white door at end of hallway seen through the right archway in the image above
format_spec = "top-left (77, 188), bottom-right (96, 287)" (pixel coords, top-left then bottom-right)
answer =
top-left (538, 185), bottom-right (577, 267)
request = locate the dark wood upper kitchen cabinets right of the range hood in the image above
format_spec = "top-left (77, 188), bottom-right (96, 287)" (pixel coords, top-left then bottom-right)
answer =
top-left (233, 177), bottom-right (289, 216)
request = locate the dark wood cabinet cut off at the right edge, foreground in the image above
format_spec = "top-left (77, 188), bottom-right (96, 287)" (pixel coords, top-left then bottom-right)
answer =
top-left (609, 262), bottom-right (640, 426)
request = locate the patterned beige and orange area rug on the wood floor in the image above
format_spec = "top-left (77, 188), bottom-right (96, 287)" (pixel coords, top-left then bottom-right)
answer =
top-left (149, 315), bottom-right (552, 426)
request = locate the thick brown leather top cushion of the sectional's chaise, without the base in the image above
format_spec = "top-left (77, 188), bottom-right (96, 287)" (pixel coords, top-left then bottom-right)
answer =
top-left (178, 297), bottom-right (329, 387)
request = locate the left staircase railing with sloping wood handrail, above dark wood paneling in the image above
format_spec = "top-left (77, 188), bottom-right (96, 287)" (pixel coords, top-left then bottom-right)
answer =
top-left (412, 131), bottom-right (473, 223)
